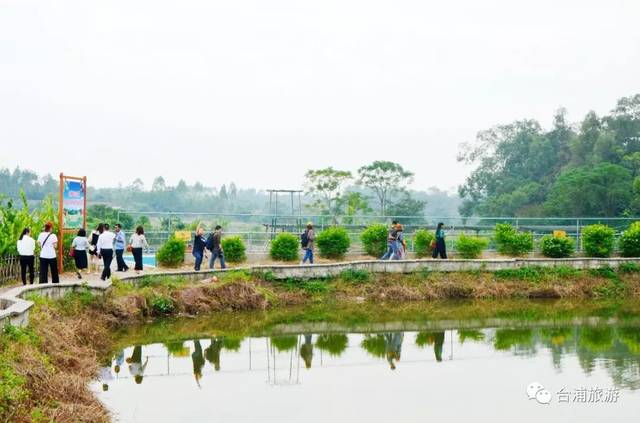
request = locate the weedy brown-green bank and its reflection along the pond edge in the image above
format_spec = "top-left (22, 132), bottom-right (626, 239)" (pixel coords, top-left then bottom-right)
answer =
top-left (0, 264), bottom-right (640, 422)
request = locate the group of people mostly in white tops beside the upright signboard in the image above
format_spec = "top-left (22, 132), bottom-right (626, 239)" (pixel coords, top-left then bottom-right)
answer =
top-left (17, 222), bottom-right (149, 285)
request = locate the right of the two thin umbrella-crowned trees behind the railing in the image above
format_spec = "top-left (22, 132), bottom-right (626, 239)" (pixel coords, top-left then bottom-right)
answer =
top-left (358, 161), bottom-right (413, 216)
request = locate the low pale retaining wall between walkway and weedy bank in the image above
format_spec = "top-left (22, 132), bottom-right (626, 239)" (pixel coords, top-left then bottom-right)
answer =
top-left (0, 258), bottom-right (640, 327)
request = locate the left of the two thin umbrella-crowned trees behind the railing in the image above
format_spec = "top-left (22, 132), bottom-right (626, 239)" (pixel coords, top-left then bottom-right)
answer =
top-left (305, 167), bottom-right (353, 223)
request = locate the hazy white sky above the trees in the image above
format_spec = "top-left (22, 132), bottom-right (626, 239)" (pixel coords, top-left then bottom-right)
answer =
top-left (0, 0), bottom-right (640, 189)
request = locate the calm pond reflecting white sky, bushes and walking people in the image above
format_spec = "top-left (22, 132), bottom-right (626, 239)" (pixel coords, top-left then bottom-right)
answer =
top-left (93, 305), bottom-right (640, 422)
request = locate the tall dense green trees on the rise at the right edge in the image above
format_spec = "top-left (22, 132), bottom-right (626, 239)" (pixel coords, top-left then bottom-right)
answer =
top-left (459, 94), bottom-right (640, 217)
